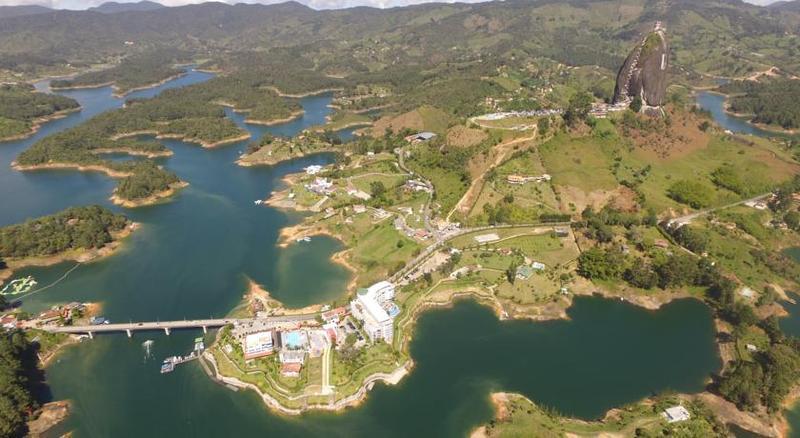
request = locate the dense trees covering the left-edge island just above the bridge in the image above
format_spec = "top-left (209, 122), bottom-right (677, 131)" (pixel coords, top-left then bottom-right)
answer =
top-left (0, 205), bottom-right (129, 258)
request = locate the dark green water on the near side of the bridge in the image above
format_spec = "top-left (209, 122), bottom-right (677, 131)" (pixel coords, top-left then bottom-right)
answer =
top-left (42, 298), bottom-right (720, 437)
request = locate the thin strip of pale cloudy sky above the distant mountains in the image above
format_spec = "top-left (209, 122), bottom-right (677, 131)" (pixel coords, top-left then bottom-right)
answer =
top-left (0, 0), bottom-right (777, 9)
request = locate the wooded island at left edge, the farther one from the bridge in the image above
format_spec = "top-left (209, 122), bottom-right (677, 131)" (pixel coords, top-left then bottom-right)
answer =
top-left (0, 84), bottom-right (80, 141)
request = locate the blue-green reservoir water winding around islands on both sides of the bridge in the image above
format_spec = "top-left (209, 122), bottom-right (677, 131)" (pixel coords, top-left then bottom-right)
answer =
top-left (0, 71), bottom-right (720, 437)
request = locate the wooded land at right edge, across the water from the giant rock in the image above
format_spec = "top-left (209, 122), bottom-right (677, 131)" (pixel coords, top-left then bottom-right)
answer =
top-left (718, 78), bottom-right (800, 130)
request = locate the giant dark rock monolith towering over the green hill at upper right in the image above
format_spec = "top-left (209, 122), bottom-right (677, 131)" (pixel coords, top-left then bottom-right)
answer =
top-left (614, 22), bottom-right (669, 109)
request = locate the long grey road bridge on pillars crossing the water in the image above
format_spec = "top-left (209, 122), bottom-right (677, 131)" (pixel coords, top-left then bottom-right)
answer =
top-left (37, 313), bottom-right (317, 338)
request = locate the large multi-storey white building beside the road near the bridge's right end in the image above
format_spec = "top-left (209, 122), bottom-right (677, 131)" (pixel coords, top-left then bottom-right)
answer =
top-left (350, 281), bottom-right (395, 343)
